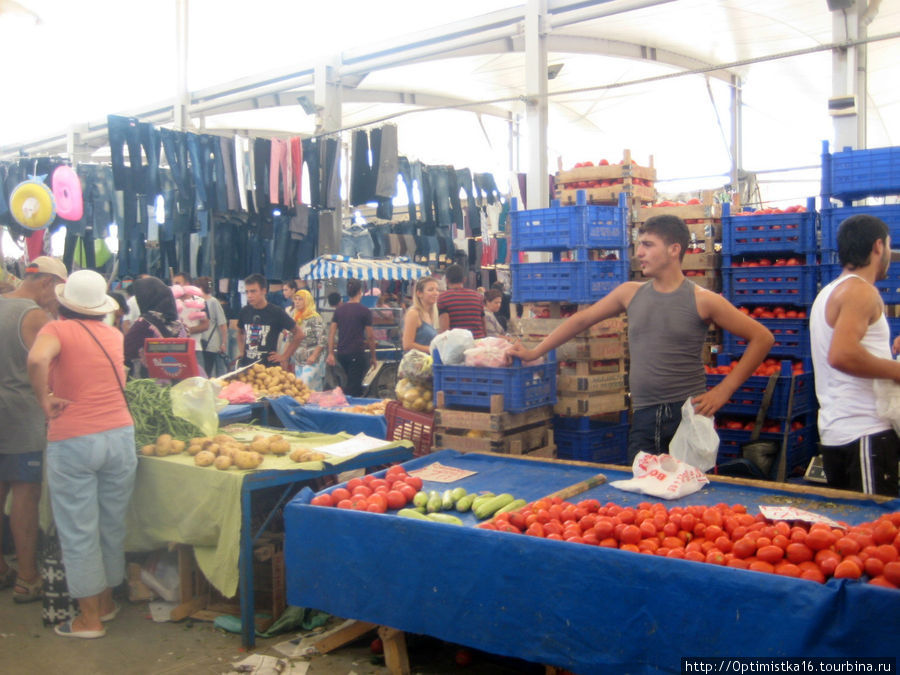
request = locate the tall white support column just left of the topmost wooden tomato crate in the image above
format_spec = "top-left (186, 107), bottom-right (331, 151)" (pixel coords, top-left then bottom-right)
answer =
top-left (525, 0), bottom-right (550, 209)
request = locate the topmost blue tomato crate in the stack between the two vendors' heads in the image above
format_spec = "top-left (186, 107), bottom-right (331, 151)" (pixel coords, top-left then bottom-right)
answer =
top-left (722, 198), bottom-right (818, 255)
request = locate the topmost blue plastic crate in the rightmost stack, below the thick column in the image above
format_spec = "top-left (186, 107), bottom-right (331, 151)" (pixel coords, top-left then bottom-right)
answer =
top-left (822, 141), bottom-right (900, 202)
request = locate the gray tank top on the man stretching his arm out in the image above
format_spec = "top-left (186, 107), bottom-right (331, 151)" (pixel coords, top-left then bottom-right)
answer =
top-left (628, 279), bottom-right (709, 409)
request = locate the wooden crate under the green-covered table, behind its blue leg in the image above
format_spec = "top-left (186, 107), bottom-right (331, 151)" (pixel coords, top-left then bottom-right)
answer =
top-left (170, 533), bottom-right (287, 632)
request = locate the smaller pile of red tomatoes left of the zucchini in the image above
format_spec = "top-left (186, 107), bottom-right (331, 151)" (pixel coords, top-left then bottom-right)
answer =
top-left (310, 466), bottom-right (422, 513)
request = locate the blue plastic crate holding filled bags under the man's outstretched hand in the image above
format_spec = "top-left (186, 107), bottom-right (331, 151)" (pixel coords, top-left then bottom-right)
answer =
top-left (432, 350), bottom-right (557, 412)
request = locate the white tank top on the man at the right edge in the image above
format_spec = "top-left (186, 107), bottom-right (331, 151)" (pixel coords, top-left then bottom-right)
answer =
top-left (809, 274), bottom-right (893, 445)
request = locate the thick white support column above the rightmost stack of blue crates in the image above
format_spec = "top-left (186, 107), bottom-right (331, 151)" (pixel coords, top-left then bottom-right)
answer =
top-left (829, 0), bottom-right (868, 152)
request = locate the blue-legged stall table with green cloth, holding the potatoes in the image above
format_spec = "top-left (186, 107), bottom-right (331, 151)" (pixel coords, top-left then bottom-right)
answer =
top-left (125, 425), bottom-right (412, 646)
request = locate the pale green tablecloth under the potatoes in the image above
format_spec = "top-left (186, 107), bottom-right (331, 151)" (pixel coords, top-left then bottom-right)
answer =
top-left (125, 424), bottom-right (402, 597)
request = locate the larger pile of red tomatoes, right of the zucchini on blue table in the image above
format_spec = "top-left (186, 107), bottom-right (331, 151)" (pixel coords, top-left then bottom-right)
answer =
top-left (478, 497), bottom-right (900, 588)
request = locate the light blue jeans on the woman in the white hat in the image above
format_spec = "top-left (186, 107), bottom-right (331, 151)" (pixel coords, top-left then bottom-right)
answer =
top-left (47, 426), bottom-right (137, 598)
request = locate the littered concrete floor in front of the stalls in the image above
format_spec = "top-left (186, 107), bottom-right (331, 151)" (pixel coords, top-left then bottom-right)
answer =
top-left (0, 589), bottom-right (543, 675)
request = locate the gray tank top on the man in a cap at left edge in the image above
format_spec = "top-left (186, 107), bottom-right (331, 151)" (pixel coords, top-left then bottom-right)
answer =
top-left (0, 297), bottom-right (47, 455)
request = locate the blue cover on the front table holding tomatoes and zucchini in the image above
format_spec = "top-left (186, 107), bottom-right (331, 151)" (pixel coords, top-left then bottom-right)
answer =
top-left (284, 450), bottom-right (900, 675)
